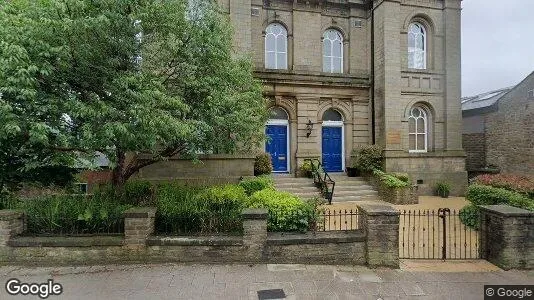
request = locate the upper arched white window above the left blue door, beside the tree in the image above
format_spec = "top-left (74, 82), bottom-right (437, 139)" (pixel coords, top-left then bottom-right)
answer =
top-left (265, 23), bottom-right (287, 70)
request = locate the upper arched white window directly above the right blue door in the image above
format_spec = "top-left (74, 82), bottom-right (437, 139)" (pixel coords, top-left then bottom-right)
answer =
top-left (323, 29), bottom-right (343, 73)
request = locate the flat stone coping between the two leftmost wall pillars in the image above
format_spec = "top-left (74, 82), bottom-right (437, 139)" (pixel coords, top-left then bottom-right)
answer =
top-left (7, 235), bottom-right (124, 247)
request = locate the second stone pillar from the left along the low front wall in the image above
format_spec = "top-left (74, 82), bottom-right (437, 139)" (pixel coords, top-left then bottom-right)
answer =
top-left (124, 207), bottom-right (156, 248)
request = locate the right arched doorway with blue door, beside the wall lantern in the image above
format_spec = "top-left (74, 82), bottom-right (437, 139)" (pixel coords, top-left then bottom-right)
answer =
top-left (322, 109), bottom-right (345, 172)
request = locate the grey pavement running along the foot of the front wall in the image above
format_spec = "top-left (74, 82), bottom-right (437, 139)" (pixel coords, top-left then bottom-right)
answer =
top-left (0, 261), bottom-right (534, 300)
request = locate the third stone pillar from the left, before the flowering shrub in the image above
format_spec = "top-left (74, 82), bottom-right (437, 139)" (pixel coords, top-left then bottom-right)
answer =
top-left (241, 208), bottom-right (268, 261)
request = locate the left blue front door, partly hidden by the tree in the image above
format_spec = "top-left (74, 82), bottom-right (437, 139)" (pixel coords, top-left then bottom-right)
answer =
top-left (265, 125), bottom-right (288, 172)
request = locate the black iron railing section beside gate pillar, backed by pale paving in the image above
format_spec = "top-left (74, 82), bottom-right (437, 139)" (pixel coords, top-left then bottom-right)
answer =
top-left (311, 209), bottom-right (361, 231)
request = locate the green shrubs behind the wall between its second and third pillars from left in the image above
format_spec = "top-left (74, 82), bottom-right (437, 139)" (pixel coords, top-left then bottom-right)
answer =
top-left (155, 183), bottom-right (248, 234)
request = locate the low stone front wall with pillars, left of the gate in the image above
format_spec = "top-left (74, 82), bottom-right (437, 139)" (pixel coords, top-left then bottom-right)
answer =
top-left (0, 205), bottom-right (399, 267)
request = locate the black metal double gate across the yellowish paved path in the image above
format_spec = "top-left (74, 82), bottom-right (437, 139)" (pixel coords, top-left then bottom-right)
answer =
top-left (399, 208), bottom-right (480, 259)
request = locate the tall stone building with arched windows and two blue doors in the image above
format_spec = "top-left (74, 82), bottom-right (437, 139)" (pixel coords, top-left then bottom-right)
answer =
top-left (219, 0), bottom-right (467, 194)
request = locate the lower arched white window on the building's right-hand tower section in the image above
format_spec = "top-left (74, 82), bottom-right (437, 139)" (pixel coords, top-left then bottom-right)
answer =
top-left (408, 106), bottom-right (428, 152)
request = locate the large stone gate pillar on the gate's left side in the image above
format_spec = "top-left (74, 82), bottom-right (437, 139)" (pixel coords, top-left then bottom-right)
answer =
top-left (358, 204), bottom-right (399, 268)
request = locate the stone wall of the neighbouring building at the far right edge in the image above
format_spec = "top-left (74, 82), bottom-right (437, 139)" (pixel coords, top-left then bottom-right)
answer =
top-left (486, 73), bottom-right (534, 175)
